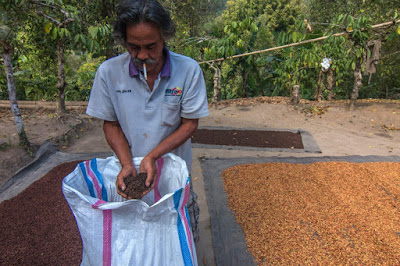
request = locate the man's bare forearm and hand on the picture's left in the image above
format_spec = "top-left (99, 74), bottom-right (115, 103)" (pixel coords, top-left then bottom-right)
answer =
top-left (103, 121), bottom-right (137, 198)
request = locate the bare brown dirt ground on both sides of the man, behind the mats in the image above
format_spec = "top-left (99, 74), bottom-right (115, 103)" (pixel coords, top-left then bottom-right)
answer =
top-left (0, 97), bottom-right (400, 186)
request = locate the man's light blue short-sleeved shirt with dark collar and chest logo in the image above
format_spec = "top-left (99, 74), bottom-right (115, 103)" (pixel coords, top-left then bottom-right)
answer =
top-left (86, 49), bottom-right (209, 172)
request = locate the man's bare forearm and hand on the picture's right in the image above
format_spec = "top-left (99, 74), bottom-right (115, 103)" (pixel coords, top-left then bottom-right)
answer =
top-left (139, 118), bottom-right (199, 189)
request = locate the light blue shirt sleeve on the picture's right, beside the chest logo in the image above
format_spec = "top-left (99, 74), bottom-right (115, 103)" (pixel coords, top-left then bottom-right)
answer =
top-left (181, 62), bottom-right (209, 119)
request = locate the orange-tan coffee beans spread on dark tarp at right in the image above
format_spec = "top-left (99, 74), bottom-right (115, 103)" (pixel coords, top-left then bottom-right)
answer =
top-left (222, 162), bottom-right (400, 265)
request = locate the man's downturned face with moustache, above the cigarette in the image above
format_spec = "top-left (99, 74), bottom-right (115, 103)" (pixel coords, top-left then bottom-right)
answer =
top-left (126, 22), bottom-right (164, 74)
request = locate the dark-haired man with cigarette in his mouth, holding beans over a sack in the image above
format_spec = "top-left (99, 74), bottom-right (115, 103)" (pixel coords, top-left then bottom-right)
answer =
top-left (87, 0), bottom-right (209, 241)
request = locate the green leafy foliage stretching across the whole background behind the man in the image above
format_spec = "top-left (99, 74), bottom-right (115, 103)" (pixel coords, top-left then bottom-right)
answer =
top-left (0, 0), bottom-right (400, 103)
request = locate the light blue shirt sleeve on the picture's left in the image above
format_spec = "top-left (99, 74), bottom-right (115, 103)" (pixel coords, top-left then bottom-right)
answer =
top-left (86, 64), bottom-right (117, 121)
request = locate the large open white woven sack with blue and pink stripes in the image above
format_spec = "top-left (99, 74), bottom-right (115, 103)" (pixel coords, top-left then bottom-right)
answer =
top-left (62, 153), bottom-right (197, 266)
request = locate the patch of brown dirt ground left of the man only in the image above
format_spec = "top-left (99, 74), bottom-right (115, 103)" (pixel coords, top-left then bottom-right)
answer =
top-left (0, 105), bottom-right (106, 186)
